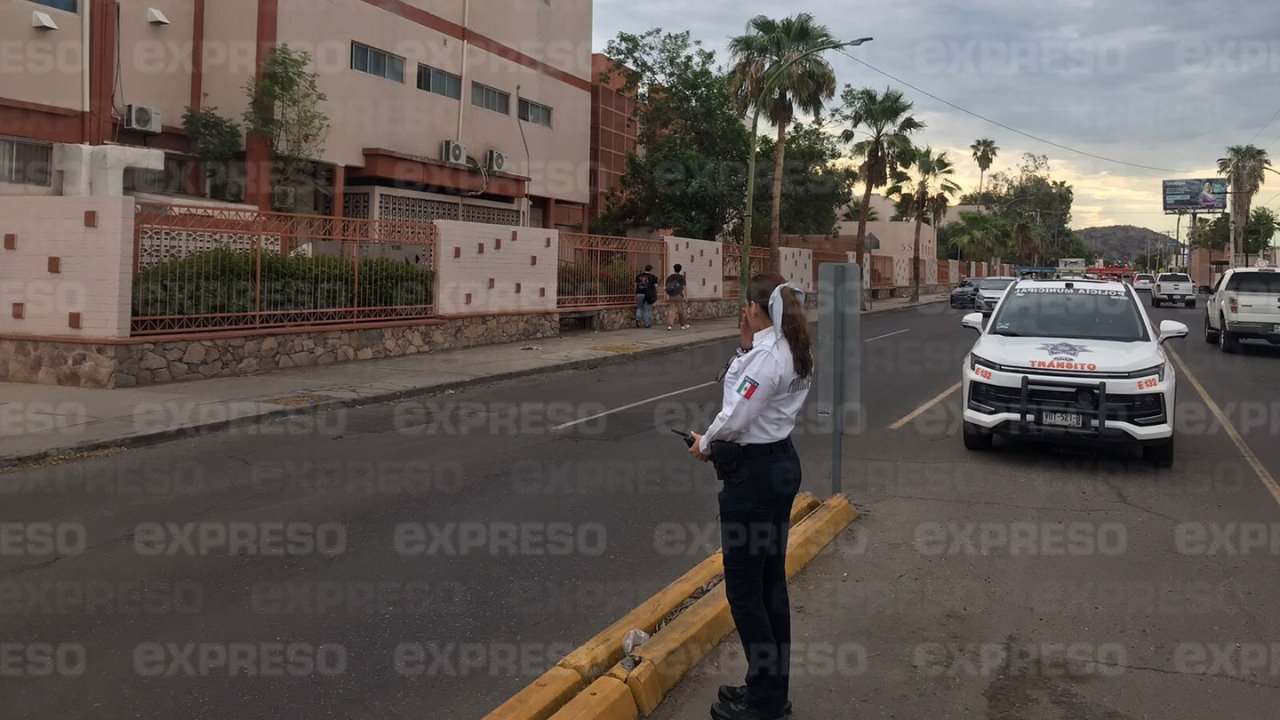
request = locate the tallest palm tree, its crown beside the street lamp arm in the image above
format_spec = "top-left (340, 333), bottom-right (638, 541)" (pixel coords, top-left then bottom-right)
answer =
top-left (728, 13), bottom-right (836, 263)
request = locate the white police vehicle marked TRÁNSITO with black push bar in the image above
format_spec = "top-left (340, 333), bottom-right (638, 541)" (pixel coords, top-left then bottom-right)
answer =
top-left (961, 274), bottom-right (1188, 468)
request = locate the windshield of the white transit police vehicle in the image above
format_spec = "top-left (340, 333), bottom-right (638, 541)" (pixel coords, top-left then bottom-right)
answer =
top-left (991, 287), bottom-right (1148, 342)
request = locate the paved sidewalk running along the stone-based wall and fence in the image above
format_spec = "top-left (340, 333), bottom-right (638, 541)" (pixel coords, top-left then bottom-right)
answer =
top-left (0, 295), bottom-right (946, 466)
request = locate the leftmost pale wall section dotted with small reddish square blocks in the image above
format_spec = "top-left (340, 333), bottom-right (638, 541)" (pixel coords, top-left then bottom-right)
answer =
top-left (0, 197), bottom-right (133, 338)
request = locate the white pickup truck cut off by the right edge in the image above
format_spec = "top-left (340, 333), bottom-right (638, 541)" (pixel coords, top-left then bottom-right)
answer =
top-left (1204, 268), bottom-right (1280, 352)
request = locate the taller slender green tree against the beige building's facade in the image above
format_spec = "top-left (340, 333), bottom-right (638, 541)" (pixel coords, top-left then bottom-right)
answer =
top-left (244, 45), bottom-right (329, 211)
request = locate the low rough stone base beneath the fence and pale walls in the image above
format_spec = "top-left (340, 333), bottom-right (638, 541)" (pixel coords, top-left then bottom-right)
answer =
top-left (0, 313), bottom-right (559, 388)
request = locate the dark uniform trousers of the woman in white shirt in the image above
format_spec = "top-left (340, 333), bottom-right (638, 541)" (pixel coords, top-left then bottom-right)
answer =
top-left (717, 438), bottom-right (800, 712)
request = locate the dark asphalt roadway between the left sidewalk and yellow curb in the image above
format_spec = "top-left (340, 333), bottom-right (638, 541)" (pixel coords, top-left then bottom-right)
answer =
top-left (4, 303), bottom-right (952, 716)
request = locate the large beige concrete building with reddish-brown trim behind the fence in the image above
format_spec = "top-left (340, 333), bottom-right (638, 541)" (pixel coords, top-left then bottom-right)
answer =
top-left (0, 0), bottom-right (593, 229)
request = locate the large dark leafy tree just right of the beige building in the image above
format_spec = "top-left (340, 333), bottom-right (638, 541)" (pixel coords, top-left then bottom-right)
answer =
top-left (595, 28), bottom-right (750, 240)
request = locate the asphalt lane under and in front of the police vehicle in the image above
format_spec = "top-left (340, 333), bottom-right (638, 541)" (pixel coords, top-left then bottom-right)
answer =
top-left (655, 366), bottom-right (1280, 720)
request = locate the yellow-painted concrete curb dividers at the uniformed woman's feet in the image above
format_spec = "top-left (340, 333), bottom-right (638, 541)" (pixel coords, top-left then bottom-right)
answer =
top-left (485, 493), bottom-right (856, 720)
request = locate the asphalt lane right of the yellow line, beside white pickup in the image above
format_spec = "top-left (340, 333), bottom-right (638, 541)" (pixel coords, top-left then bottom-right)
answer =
top-left (1148, 295), bottom-right (1280, 478)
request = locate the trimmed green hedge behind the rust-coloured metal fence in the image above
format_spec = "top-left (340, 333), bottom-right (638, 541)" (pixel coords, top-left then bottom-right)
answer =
top-left (133, 249), bottom-right (434, 318)
